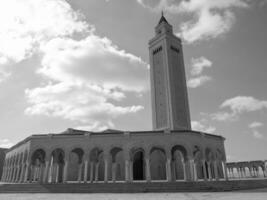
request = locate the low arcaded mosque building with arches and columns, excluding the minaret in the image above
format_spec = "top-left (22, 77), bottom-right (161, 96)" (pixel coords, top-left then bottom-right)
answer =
top-left (0, 131), bottom-right (226, 182)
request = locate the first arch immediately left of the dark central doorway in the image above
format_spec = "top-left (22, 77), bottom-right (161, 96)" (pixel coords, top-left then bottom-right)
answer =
top-left (109, 147), bottom-right (125, 181)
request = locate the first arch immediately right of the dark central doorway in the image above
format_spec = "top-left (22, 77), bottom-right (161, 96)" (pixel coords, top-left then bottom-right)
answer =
top-left (149, 147), bottom-right (167, 180)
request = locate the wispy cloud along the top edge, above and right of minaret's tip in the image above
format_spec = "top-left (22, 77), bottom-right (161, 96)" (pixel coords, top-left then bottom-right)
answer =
top-left (137, 0), bottom-right (248, 43)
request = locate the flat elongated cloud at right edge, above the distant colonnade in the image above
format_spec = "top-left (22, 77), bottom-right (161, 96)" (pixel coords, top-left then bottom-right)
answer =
top-left (214, 96), bottom-right (267, 121)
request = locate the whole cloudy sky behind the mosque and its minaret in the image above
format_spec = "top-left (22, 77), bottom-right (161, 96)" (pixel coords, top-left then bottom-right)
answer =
top-left (0, 0), bottom-right (267, 161)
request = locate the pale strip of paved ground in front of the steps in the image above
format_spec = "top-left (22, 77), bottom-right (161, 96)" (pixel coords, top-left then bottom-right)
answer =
top-left (0, 192), bottom-right (267, 200)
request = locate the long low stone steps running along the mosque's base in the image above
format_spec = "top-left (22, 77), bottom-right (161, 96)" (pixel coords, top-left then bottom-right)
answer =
top-left (0, 179), bottom-right (267, 193)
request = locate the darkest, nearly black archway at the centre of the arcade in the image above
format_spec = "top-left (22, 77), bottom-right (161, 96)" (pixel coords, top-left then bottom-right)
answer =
top-left (133, 150), bottom-right (145, 180)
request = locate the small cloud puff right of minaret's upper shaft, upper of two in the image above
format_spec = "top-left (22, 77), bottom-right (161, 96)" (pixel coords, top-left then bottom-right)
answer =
top-left (190, 56), bottom-right (212, 76)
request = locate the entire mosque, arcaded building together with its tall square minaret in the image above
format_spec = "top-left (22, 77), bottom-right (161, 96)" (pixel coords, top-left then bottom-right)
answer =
top-left (1, 15), bottom-right (262, 187)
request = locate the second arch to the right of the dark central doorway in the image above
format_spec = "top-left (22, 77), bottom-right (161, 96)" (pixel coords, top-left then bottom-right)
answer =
top-left (171, 145), bottom-right (188, 180)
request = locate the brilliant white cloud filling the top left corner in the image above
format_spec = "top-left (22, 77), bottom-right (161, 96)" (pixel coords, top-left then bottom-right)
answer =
top-left (0, 0), bottom-right (89, 65)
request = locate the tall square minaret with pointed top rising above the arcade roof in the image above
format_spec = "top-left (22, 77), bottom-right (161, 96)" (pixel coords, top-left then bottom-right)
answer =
top-left (149, 13), bottom-right (191, 130)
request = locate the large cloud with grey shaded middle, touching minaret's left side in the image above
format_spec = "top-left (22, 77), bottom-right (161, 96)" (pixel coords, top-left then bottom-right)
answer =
top-left (39, 34), bottom-right (148, 92)
